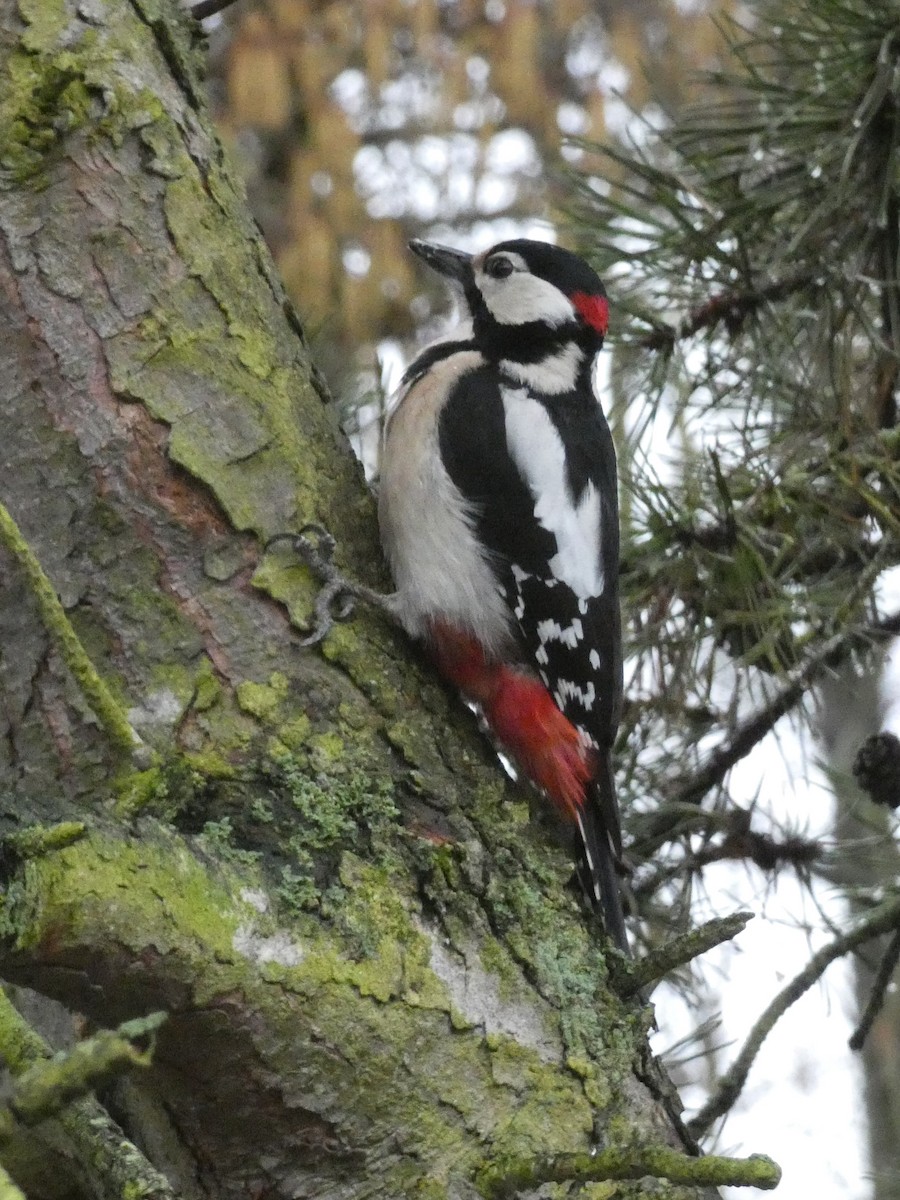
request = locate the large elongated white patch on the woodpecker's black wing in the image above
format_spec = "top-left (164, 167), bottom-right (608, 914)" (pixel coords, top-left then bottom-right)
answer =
top-left (500, 388), bottom-right (604, 599)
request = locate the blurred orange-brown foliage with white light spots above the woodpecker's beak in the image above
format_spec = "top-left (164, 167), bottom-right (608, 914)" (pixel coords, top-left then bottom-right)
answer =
top-left (204, 0), bottom-right (732, 394)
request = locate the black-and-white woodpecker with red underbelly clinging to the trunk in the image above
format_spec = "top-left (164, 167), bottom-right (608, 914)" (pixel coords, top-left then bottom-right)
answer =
top-left (379, 231), bottom-right (628, 953)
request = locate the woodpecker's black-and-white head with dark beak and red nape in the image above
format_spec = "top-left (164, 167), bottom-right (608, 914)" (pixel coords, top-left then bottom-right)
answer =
top-left (409, 238), bottom-right (608, 358)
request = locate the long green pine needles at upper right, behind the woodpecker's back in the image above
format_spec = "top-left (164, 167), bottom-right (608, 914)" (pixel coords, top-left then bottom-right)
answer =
top-left (571, 0), bottom-right (900, 912)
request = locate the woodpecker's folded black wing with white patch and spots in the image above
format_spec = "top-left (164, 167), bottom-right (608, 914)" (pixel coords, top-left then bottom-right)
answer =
top-left (439, 367), bottom-right (622, 751)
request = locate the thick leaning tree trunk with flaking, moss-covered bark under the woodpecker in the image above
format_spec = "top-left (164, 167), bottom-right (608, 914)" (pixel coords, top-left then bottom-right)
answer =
top-left (0, 0), bottom-right (729, 1200)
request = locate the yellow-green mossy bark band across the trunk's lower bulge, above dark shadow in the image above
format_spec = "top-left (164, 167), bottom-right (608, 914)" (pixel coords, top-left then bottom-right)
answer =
top-left (0, 830), bottom-right (628, 1194)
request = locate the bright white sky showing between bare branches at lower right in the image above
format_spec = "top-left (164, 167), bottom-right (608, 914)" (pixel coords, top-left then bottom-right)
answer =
top-left (653, 719), bottom-right (870, 1200)
